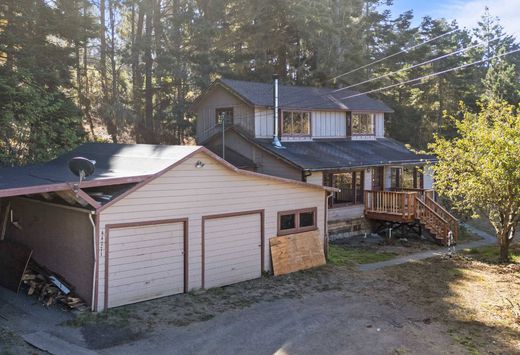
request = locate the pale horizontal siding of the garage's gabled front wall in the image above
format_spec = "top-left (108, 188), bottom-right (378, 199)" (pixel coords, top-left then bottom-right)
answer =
top-left (98, 152), bottom-right (325, 309)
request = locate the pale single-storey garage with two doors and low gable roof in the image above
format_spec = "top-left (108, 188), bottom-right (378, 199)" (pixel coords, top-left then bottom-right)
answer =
top-left (0, 143), bottom-right (333, 311)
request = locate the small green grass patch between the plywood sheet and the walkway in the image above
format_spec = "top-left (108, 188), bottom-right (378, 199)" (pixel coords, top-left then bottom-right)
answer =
top-left (329, 245), bottom-right (398, 266)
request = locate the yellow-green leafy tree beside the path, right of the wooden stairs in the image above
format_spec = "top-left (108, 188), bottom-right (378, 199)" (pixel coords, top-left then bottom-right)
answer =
top-left (429, 101), bottom-right (520, 262)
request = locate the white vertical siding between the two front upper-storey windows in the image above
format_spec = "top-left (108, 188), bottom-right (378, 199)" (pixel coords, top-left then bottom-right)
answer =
top-left (311, 111), bottom-right (347, 138)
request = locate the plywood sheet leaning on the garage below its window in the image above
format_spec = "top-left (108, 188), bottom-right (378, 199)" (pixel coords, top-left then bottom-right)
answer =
top-left (269, 231), bottom-right (326, 275)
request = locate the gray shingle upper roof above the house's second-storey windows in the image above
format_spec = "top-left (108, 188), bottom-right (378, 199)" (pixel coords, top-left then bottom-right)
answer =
top-left (218, 79), bottom-right (393, 112)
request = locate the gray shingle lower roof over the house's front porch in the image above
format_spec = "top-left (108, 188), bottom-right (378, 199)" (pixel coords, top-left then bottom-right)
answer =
top-left (255, 138), bottom-right (435, 170)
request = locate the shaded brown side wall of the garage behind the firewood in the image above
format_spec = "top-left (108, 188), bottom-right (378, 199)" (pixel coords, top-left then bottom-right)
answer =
top-left (7, 198), bottom-right (94, 304)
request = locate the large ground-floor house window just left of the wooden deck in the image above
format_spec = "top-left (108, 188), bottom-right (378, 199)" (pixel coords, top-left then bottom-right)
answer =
top-left (324, 171), bottom-right (365, 206)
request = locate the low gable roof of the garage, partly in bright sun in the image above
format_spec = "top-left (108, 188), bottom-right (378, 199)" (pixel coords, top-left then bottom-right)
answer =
top-left (0, 143), bottom-right (334, 197)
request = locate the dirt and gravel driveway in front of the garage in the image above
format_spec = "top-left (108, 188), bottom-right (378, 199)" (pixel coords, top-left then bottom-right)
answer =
top-left (0, 243), bottom-right (520, 354)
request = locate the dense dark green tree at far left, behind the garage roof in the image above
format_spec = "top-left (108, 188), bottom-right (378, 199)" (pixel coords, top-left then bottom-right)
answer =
top-left (0, 0), bottom-right (85, 165)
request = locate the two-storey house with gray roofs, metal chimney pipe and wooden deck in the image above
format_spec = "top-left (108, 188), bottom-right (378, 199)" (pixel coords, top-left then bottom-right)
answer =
top-left (191, 78), bottom-right (460, 240)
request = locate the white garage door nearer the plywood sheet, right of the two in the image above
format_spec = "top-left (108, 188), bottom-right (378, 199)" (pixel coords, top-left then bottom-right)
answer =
top-left (203, 212), bottom-right (263, 288)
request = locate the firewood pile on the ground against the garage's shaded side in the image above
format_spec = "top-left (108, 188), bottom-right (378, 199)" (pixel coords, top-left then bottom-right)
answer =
top-left (22, 260), bottom-right (88, 311)
